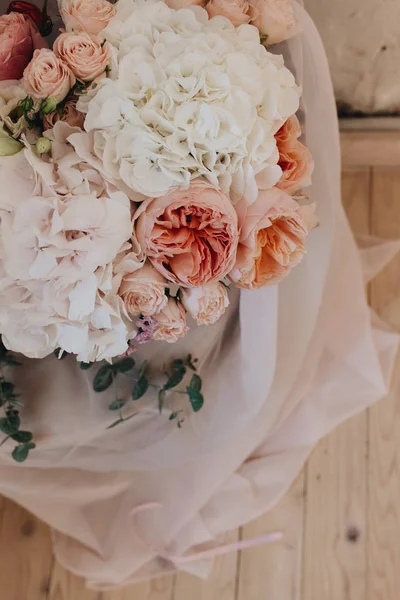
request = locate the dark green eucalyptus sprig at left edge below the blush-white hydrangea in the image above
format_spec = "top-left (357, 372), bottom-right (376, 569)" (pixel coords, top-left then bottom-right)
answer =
top-left (0, 340), bottom-right (36, 462)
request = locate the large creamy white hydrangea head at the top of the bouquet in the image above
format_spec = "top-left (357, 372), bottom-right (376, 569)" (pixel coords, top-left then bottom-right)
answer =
top-left (78, 0), bottom-right (300, 203)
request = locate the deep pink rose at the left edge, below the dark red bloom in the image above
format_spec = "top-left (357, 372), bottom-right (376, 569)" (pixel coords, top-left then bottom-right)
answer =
top-left (0, 13), bottom-right (47, 81)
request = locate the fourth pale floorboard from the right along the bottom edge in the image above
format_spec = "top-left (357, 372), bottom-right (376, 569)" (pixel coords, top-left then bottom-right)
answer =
top-left (173, 530), bottom-right (239, 600)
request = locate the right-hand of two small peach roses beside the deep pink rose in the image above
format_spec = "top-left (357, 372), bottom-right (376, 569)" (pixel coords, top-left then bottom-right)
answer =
top-left (54, 32), bottom-right (110, 81)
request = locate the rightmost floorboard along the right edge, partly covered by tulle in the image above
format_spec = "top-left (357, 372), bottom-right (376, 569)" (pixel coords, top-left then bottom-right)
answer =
top-left (367, 170), bottom-right (400, 600)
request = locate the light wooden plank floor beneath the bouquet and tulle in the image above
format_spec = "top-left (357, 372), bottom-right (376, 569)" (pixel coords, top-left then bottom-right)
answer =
top-left (0, 158), bottom-right (400, 600)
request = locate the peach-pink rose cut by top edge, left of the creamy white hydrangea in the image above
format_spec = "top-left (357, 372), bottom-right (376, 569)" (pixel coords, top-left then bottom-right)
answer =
top-left (60, 0), bottom-right (117, 35)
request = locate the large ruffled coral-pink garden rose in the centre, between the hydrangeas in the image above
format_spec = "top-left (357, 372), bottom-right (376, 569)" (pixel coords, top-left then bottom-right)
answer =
top-left (134, 182), bottom-right (239, 287)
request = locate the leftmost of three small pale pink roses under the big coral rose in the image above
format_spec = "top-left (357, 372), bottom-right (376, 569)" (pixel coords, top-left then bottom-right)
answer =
top-left (118, 264), bottom-right (168, 317)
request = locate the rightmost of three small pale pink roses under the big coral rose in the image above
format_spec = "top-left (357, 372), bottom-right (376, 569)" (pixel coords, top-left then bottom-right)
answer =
top-left (181, 281), bottom-right (229, 325)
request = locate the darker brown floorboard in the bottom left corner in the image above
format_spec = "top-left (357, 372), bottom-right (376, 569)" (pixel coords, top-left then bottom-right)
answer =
top-left (0, 499), bottom-right (53, 600)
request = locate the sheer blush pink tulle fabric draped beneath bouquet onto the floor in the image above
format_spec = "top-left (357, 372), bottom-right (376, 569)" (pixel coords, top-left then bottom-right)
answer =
top-left (0, 3), bottom-right (398, 589)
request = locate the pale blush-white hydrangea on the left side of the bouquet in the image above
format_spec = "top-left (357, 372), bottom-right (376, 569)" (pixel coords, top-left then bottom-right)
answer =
top-left (0, 123), bottom-right (143, 362)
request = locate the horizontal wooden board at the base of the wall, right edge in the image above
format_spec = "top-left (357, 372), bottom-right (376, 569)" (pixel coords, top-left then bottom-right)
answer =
top-left (340, 131), bottom-right (400, 169)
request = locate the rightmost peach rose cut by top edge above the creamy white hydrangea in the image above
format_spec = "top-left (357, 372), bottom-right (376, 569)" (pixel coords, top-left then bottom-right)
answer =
top-left (249, 0), bottom-right (298, 45)
